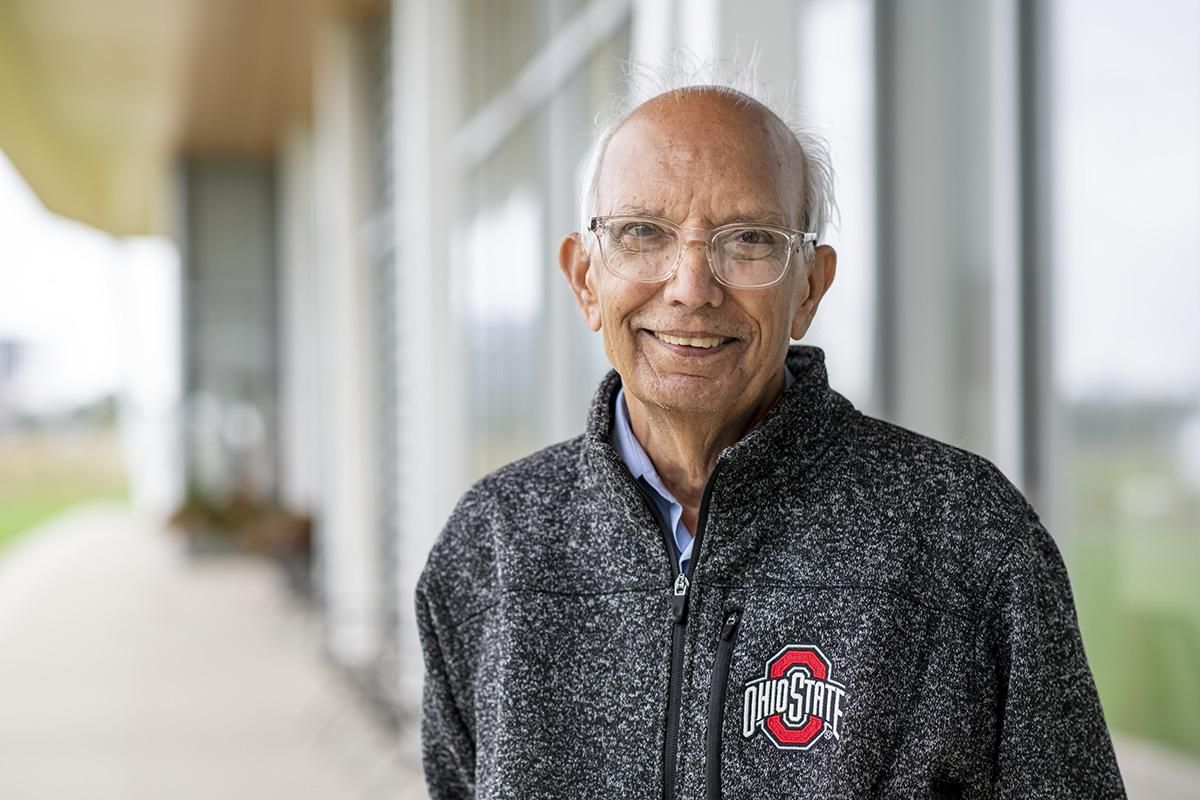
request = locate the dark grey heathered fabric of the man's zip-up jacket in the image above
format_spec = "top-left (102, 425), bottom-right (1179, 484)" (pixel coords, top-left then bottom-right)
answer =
top-left (416, 345), bottom-right (1124, 800)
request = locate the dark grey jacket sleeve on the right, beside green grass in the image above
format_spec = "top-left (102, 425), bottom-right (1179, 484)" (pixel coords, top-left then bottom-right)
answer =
top-left (990, 504), bottom-right (1126, 800)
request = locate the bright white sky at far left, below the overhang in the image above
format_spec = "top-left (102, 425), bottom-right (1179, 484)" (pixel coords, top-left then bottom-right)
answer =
top-left (0, 152), bottom-right (178, 413)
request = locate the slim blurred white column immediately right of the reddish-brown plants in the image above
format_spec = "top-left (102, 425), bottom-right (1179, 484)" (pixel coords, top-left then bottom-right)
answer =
top-left (313, 18), bottom-right (382, 668)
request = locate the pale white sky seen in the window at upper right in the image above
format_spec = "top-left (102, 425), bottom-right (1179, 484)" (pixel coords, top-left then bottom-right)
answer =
top-left (1051, 0), bottom-right (1200, 401)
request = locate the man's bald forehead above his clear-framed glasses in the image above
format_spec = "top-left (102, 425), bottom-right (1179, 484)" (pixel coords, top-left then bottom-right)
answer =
top-left (598, 94), bottom-right (803, 225)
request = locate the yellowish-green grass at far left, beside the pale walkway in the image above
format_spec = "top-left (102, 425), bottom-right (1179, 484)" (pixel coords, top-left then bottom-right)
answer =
top-left (0, 431), bottom-right (126, 553)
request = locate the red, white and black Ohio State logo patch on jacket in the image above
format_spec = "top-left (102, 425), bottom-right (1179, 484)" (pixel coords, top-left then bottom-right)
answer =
top-left (742, 644), bottom-right (846, 750)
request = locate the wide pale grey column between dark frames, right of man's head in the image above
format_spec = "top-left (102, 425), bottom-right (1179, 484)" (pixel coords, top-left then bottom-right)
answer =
top-left (876, 0), bottom-right (1015, 463)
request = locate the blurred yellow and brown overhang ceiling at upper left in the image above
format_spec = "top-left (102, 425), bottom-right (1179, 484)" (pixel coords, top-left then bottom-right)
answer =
top-left (0, 0), bottom-right (377, 235)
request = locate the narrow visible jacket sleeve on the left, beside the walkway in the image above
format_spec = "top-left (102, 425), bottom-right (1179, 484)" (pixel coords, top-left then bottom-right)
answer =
top-left (416, 579), bottom-right (475, 800)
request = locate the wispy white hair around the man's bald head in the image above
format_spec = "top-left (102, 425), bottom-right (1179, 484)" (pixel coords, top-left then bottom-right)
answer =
top-left (580, 50), bottom-right (838, 245)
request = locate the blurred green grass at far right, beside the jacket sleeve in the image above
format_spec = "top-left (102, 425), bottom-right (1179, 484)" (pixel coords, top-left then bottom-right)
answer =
top-left (1067, 451), bottom-right (1200, 756)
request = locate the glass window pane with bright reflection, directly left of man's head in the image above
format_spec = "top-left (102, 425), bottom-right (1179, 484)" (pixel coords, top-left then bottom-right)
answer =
top-left (450, 23), bottom-right (629, 476)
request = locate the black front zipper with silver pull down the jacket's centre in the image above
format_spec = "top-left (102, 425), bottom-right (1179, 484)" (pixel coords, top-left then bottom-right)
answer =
top-left (634, 462), bottom-right (721, 800)
